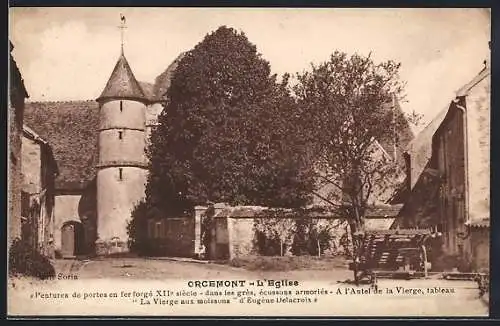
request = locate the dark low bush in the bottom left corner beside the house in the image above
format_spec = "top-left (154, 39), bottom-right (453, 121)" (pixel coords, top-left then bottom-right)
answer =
top-left (9, 238), bottom-right (55, 279)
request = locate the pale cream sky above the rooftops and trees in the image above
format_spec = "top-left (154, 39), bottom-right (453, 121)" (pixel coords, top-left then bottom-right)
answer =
top-left (9, 7), bottom-right (490, 133)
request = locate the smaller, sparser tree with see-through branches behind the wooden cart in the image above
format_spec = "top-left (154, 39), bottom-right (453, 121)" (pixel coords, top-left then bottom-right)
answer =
top-left (294, 52), bottom-right (409, 242)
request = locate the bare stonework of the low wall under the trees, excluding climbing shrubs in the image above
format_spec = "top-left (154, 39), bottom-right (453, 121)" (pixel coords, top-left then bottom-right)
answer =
top-left (147, 204), bottom-right (392, 260)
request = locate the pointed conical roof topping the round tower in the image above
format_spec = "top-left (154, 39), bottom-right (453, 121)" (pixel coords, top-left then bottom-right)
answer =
top-left (97, 52), bottom-right (146, 101)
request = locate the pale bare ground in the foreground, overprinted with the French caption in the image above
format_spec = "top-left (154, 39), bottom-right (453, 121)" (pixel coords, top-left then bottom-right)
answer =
top-left (8, 258), bottom-right (488, 316)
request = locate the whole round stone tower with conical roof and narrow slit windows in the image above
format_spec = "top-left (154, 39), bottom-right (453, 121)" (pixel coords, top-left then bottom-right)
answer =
top-left (96, 49), bottom-right (147, 254)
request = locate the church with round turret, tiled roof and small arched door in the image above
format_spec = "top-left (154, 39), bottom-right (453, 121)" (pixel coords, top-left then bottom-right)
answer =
top-left (25, 34), bottom-right (181, 257)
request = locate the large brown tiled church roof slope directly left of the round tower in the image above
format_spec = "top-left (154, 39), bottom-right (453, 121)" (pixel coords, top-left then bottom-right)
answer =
top-left (24, 101), bottom-right (99, 189)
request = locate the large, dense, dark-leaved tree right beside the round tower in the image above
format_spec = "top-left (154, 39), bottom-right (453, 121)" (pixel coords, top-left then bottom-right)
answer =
top-left (146, 26), bottom-right (313, 215)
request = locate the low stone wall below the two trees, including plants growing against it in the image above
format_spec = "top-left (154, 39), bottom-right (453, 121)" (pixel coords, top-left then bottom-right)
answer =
top-left (144, 204), bottom-right (393, 259)
